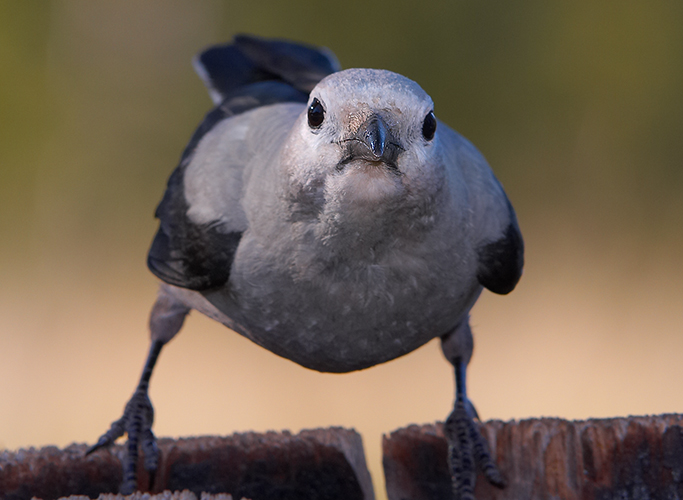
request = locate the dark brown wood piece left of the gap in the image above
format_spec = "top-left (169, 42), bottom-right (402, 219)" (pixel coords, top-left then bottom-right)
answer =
top-left (0, 428), bottom-right (374, 500)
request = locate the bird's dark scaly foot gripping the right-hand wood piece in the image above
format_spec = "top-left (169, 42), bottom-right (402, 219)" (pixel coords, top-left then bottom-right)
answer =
top-left (444, 398), bottom-right (505, 500)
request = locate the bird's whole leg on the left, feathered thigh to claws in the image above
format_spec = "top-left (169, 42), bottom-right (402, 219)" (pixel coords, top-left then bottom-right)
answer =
top-left (86, 287), bottom-right (189, 494)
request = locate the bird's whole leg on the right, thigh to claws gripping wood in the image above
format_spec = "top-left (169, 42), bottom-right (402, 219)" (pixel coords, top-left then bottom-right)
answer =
top-left (441, 318), bottom-right (505, 500)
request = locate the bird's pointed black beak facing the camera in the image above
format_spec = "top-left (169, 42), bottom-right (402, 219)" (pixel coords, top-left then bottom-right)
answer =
top-left (342, 115), bottom-right (403, 171)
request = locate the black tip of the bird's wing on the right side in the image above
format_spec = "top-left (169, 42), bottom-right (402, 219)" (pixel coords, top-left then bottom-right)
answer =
top-left (477, 221), bottom-right (524, 295)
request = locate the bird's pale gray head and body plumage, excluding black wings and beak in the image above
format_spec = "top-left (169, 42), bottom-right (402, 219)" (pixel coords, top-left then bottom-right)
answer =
top-left (151, 65), bottom-right (517, 372)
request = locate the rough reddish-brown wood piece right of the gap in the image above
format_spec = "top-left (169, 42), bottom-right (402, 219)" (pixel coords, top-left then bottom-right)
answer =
top-left (383, 415), bottom-right (683, 500)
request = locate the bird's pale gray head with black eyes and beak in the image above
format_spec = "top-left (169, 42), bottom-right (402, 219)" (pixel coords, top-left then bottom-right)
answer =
top-left (288, 69), bottom-right (443, 213)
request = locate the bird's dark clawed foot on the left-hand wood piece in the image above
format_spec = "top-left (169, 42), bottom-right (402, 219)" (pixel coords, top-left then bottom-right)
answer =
top-left (86, 388), bottom-right (159, 495)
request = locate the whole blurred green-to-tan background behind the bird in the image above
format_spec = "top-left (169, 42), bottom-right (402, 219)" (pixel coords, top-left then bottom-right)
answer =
top-left (0, 0), bottom-right (683, 492)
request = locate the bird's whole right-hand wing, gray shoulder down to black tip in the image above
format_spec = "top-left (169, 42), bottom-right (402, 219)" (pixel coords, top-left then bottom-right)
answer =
top-left (442, 127), bottom-right (524, 294)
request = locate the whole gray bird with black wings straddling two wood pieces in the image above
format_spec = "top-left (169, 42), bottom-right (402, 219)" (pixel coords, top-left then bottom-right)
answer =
top-left (88, 36), bottom-right (524, 499)
